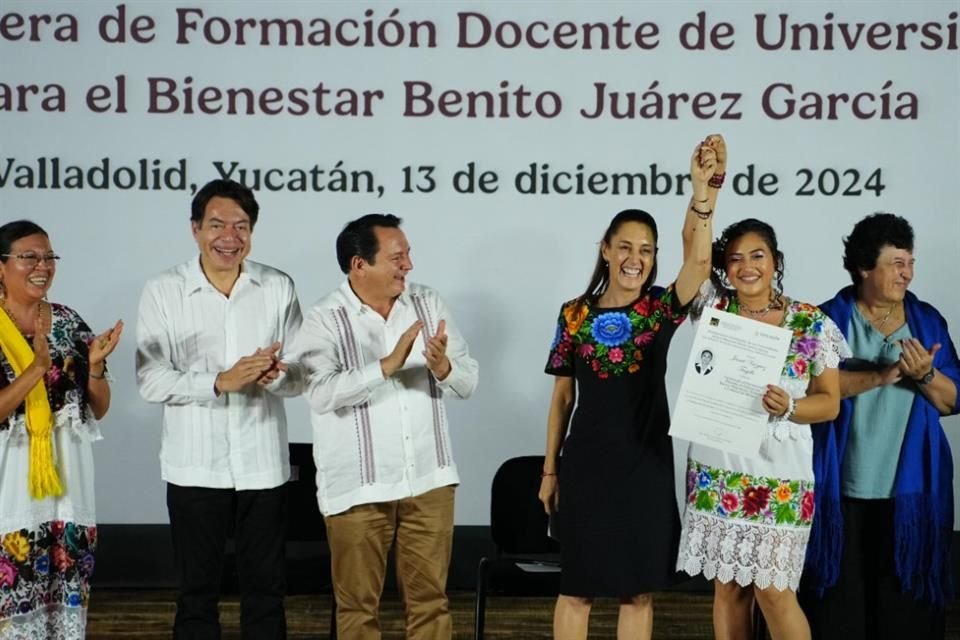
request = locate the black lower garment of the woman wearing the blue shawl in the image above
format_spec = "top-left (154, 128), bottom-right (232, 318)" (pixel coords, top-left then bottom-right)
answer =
top-left (800, 498), bottom-right (945, 640)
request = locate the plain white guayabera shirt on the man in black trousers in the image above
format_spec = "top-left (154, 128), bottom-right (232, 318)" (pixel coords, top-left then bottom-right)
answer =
top-left (137, 258), bottom-right (302, 490)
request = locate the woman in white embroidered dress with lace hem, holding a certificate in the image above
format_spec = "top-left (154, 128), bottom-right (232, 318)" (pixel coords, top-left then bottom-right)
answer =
top-left (677, 219), bottom-right (846, 640)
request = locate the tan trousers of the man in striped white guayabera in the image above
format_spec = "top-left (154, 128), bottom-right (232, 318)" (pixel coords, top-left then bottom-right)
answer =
top-left (326, 487), bottom-right (454, 640)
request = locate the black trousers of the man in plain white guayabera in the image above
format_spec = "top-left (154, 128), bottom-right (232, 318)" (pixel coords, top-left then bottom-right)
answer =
top-left (167, 483), bottom-right (287, 640)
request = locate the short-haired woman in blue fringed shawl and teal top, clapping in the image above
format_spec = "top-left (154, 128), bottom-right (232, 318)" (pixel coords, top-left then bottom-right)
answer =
top-left (803, 213), bottom-right (960, 640)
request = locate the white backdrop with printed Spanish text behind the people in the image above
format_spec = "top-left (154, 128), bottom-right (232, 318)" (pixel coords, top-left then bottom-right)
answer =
top-left (0, 0), bottom-right (960, 524)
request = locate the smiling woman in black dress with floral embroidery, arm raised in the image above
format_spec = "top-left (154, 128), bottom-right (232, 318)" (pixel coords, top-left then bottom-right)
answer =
top-left (540, 135), bottom-right (726, 639)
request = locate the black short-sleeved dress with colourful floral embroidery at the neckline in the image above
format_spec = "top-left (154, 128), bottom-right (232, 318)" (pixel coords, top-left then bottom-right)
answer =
top-left (546, 286), bottom-right (686, 598)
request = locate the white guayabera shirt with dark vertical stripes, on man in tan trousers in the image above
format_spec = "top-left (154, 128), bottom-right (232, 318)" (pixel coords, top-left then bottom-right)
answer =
top-left (296, 282), bottom-right (479, 515)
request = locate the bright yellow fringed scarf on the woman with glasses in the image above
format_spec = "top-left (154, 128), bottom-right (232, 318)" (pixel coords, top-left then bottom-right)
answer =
top-left (0, 309), bottom-right (63, 500)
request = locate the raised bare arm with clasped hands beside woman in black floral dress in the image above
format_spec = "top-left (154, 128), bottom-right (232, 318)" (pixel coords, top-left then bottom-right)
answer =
top-left (676, 134), bottom-right (727, 304)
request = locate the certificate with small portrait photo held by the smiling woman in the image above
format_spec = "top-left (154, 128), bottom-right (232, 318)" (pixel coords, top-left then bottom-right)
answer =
top-left (670, 308), bottom-right (791, 457)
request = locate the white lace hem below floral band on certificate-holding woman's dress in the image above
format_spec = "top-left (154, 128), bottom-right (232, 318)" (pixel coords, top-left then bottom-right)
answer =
top-left (677, 506), bottom-right (810, 591)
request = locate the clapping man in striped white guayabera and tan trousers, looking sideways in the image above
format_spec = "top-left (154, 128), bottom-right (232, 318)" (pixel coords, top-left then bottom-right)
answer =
top-left (296, 214), bottom-right (478, 640)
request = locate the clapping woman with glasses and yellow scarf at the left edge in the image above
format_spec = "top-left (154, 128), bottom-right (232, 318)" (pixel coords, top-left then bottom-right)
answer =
top-left (0, 220), bottom-right (123, 640)
